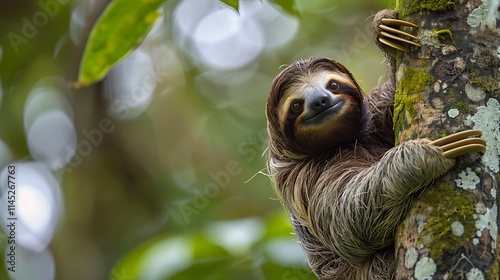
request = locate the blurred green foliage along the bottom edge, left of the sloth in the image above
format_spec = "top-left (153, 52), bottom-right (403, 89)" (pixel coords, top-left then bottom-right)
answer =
top-left (111, 212), bottom-right (316, 280)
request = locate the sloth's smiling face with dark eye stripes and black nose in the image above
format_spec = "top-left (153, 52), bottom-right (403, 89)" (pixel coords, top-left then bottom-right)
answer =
top-left (278, 69), bottom-right (362, 152)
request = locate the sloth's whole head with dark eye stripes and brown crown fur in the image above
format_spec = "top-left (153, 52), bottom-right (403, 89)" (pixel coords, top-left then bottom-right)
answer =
top-left (266, 58), bottom-right (363, 158)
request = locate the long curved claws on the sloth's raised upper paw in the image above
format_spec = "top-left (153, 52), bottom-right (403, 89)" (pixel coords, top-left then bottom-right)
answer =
top-left (377, 18), bottom-right (420, 52)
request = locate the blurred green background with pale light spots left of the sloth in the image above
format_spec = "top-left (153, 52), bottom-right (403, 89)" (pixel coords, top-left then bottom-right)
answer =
top-left (0, 0), bottom-right (394, 280)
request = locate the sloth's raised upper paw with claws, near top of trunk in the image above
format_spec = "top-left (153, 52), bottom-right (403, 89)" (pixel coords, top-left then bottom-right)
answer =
top-left (372, 10), bottom-right (420, 55)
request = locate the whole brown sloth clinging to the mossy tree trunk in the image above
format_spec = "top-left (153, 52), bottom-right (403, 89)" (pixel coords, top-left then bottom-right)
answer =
top-left (266, 10), bottom-right (485, 280)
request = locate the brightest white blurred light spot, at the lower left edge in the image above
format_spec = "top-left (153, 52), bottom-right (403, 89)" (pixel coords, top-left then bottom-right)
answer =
top-left (0, 162), bottom-right (63, 252)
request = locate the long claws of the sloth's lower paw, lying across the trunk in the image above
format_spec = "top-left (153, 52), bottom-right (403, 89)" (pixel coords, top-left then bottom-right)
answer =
top-left (431, 130), bottom-right (486, 159)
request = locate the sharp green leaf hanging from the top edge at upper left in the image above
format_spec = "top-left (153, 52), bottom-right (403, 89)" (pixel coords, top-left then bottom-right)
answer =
top-left (75, 0), bottom-right (165, 87)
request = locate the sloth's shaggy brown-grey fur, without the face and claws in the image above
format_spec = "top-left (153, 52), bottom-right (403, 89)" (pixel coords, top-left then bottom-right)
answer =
top-left (266, 9), bottom-right (453, 280)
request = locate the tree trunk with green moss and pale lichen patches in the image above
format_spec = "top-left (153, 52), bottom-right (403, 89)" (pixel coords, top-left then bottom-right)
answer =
top-left (394, 0), bottom-right (500, 279)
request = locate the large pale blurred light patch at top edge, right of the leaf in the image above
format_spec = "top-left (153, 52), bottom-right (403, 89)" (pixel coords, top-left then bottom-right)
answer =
top-left (174, 0), bottom-right (299, 71)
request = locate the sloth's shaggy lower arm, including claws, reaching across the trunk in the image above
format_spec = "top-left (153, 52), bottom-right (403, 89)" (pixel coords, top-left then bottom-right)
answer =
top-left (310, 130), bottom-right (486, 264)
